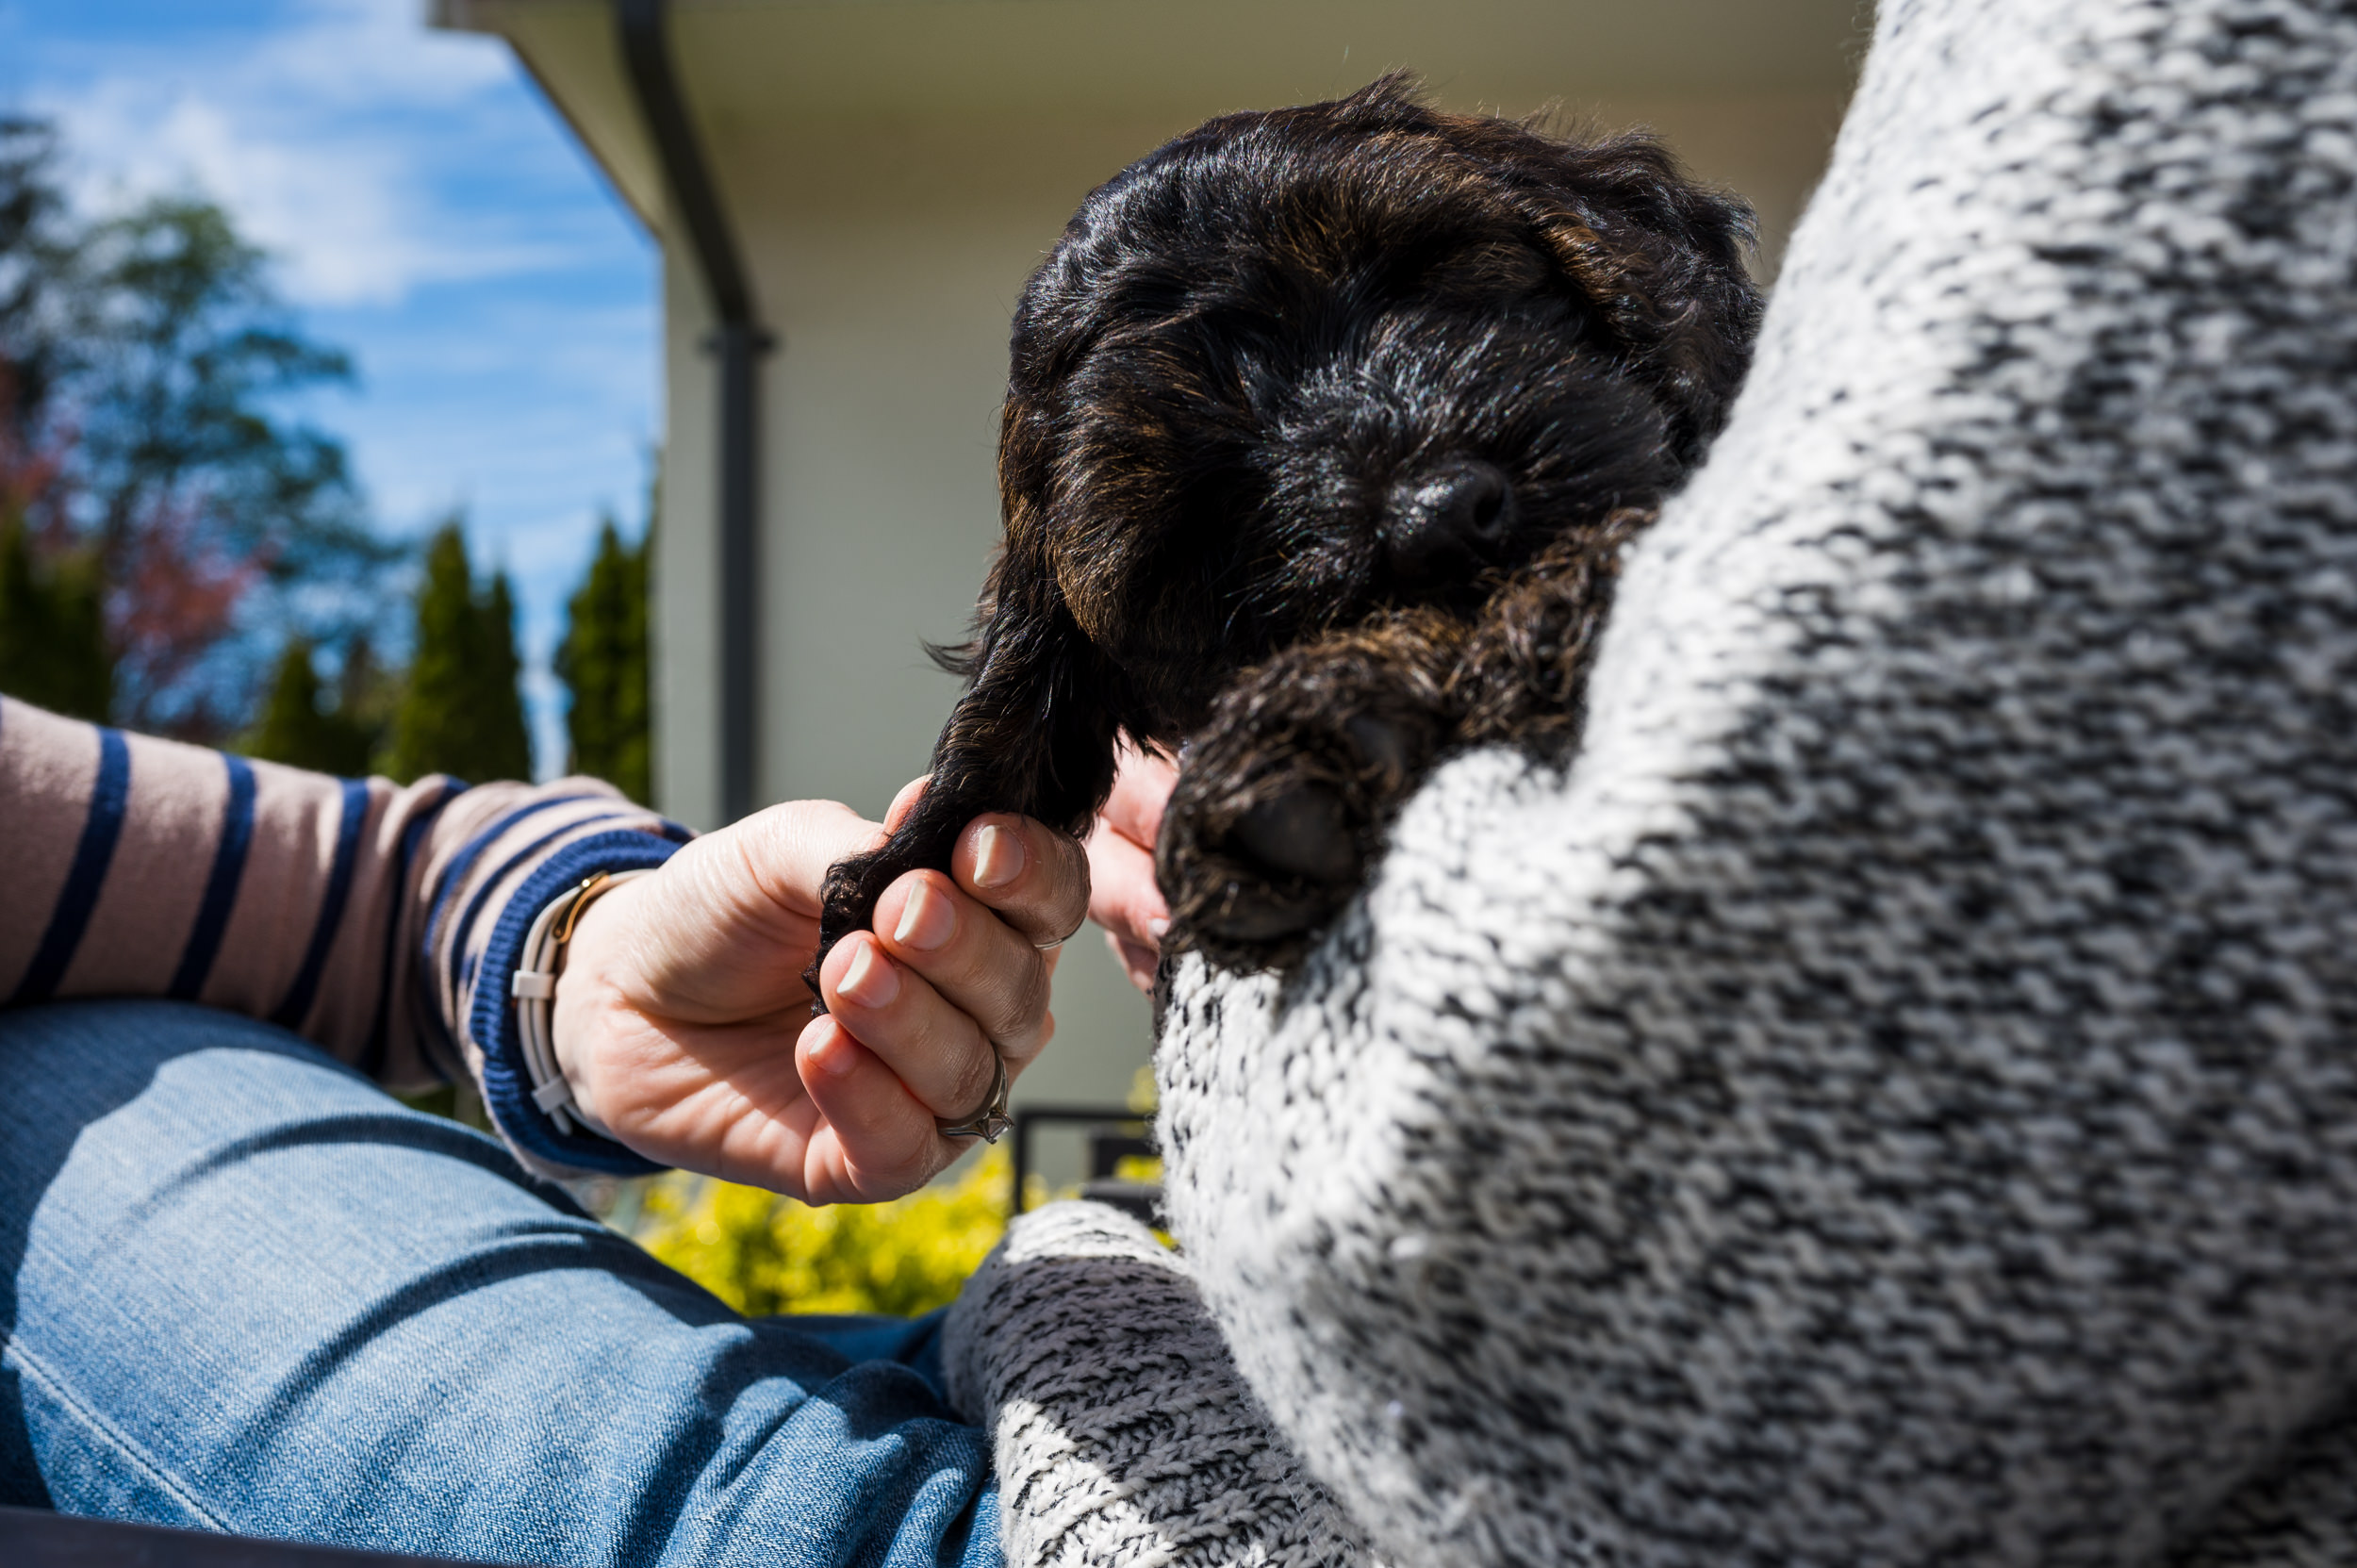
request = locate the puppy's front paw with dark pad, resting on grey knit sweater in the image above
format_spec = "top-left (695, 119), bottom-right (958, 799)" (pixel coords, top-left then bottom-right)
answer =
top-left (1155, 636), bottom-right (1447, 969)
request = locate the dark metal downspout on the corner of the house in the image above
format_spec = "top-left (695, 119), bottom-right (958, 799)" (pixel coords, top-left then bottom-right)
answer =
top-left (613, 0), bottom-right (773, 823)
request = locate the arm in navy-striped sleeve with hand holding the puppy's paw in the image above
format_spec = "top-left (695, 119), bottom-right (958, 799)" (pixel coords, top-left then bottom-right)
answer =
top-left (0, 698), bottom-right (1087, 1200)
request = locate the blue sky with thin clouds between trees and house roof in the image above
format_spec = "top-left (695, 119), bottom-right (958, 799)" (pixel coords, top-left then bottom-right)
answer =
top-left (0, 0), bottom-right (660, 773)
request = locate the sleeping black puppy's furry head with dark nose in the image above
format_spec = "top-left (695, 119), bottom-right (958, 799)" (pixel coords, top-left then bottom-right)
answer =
top-left (985, 78), bottom-right (1758, 738)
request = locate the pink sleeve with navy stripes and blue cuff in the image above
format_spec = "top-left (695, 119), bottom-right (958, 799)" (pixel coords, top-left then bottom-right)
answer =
top-left (0, 698), bottom-right (688, 1172)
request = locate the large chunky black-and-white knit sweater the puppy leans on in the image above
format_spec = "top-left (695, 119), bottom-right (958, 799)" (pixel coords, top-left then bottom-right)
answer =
top-left (948, 0), bottom-right (2357, 1568)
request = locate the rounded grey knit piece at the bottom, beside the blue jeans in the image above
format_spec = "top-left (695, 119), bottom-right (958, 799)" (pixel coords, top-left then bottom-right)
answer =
top-left (941, 1202), bottom-right (1372, 1568)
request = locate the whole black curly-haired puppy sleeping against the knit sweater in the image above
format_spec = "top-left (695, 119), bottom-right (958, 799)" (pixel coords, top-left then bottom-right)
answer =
top-left (811, 75), bottom-right (1758, 993)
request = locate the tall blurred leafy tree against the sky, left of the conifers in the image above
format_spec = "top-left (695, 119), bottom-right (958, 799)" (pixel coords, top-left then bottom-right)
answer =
top-left (78, 198), bottom-right (396, 735)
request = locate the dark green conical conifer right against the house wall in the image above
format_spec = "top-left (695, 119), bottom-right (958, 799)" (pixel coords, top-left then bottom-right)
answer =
top-left (556, 517), bottom-right (653, 804)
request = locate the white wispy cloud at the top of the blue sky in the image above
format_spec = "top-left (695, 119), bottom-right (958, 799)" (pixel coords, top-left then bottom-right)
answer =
top-left (33, 0), bottom-right (564, 306)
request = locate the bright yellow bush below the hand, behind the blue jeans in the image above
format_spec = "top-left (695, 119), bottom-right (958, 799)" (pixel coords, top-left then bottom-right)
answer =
top-left (632, 1148), bottom-right (1009, 1318)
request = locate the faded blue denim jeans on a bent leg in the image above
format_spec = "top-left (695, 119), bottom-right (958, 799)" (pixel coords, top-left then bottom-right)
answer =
top-left (0, 1002), bottom-right (999, 1568)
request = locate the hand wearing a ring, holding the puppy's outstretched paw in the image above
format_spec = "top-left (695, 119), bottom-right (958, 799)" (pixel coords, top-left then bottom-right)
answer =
top-left (554, 781), bottom-right (1089, 1202)
